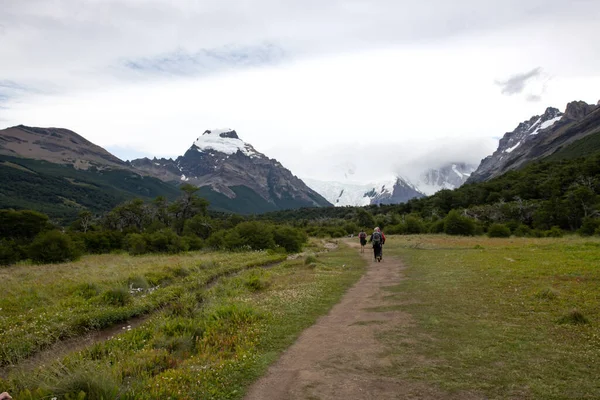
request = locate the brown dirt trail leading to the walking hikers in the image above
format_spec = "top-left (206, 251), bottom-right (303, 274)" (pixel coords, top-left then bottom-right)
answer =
top-left (246, 243), bottom-right (470, 400)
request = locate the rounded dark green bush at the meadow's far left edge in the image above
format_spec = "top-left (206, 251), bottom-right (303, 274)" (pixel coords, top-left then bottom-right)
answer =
top-left (28, 231), bottom-right (81, 264)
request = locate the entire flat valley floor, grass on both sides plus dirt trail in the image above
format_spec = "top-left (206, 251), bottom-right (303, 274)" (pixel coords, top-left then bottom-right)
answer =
top-left (0, 235), bottom-right (600, 400)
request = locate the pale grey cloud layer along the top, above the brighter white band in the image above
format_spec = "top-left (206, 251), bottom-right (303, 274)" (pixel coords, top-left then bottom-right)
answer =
top-left (0, 0), bottom-right (600, 94)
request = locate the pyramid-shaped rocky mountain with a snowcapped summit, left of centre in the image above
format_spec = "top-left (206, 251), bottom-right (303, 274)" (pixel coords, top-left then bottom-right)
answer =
top-left (130, 129), bottom-right (331, 213)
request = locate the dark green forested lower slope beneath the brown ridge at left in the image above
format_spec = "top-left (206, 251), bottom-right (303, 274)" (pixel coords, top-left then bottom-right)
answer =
top-left (0, 156), bottom-right (179, 222)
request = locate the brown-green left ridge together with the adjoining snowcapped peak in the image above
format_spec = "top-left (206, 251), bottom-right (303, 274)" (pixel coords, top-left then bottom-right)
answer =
top-left (0, 125), bottom-right (331, 221)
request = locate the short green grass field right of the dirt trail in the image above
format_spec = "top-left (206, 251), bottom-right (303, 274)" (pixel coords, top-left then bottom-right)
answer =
top-left (380, 235), bottom-right (600, 399)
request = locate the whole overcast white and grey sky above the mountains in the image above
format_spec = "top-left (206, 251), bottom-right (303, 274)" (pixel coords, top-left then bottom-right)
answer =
top-left (0, 0), bottom-right (600, 182)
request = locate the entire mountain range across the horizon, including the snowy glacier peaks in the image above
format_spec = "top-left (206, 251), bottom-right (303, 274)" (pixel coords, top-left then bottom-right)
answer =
top-left (0, 101), bottom-right (600, 221)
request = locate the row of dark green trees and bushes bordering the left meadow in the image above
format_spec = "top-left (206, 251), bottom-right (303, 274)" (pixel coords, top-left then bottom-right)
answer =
top-left (0, 184), bottom-right (308, 265)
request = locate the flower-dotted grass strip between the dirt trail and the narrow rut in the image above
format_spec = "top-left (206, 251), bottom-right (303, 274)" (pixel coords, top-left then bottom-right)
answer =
top-left (0, 242), bottom-right (365, 399)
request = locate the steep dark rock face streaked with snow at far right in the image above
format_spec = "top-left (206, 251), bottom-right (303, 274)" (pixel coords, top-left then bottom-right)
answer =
top-left (467, 101), bottom-right (600, 182)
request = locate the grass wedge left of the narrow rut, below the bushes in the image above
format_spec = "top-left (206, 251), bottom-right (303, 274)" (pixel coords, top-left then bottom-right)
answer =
top-left (0, 252), bottom-right (285, 366)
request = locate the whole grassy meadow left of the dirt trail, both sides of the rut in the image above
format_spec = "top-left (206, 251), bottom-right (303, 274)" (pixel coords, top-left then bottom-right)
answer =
top-left (0, 241), bottom-right (365, 399)
